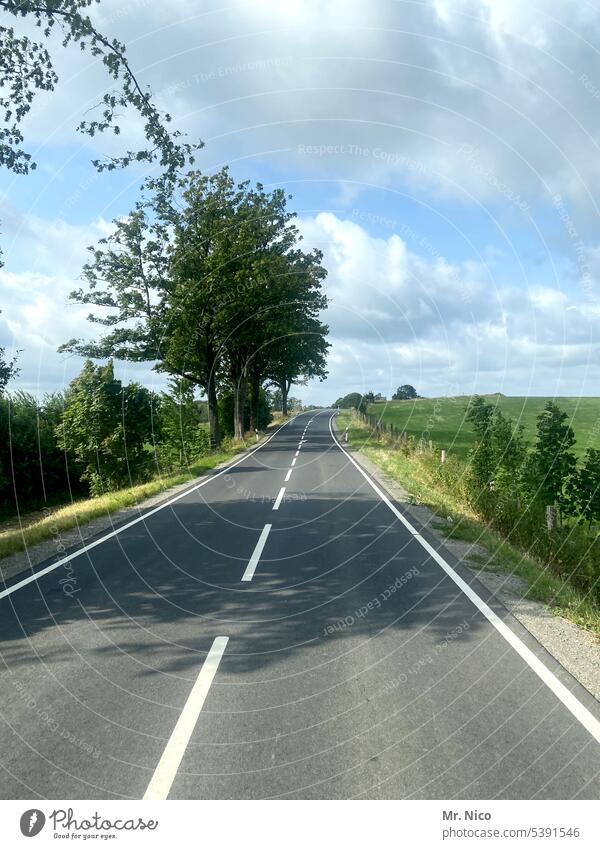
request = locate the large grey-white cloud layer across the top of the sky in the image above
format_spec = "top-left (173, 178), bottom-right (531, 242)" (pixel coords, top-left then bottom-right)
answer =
top-left (4, 0), bottom-right (600, 220)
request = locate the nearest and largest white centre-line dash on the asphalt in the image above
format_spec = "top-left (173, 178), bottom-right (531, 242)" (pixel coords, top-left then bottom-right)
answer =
top-left (144, 637), bottom-right (229, 799)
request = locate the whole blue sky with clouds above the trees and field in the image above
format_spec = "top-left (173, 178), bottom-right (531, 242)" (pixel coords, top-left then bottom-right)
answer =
top-left (0, 0), bottom-right (600, 405)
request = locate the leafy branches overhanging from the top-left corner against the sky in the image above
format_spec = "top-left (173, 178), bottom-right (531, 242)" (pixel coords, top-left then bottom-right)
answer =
top-left (0, 0), bottom-right (201, 174)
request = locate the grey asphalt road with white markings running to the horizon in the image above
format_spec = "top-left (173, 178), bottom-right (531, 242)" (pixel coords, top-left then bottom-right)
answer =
top-left (0, 412), bottom-right (600, 799)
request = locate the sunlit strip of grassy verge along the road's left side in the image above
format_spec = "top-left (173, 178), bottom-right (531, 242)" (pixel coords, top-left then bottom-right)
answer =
top-left (0, 434), bottom-right (272, 558)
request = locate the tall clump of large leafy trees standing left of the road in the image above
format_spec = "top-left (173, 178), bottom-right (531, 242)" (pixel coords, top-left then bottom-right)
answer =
top-left (60, 169), bottom-right (327, 447)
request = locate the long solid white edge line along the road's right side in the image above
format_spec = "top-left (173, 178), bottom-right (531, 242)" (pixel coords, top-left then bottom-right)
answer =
top-left (329, 416), bottom-right (600, 743)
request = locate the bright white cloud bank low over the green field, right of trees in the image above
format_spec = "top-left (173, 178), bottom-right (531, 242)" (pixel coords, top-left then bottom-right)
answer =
top-left (301, 213), bottom-right (600, 394)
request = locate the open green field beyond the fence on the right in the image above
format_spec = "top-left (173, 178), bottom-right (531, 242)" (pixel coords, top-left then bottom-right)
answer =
top-left (368, 394), bottom-right (600, 457)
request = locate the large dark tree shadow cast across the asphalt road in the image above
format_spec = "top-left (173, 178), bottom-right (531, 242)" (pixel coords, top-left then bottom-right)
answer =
top-left (0, 484), bottom-right (492, 675)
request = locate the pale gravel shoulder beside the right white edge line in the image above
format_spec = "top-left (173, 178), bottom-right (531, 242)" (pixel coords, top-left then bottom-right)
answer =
top-left (349, 449), bottom-right (600, 701)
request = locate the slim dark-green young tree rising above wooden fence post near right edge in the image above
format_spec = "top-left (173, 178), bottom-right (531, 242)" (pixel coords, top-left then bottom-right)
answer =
top-left (531, 401), bottom-right (576, 513)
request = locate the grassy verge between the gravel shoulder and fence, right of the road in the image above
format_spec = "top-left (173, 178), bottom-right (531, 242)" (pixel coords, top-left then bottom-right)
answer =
top-left (337, 411), bottom-right (600, 635)
